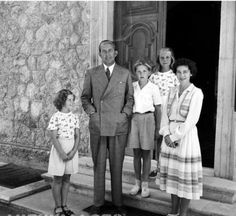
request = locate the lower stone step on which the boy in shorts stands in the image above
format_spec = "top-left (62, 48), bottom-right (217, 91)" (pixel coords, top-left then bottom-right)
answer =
top-left (42, 173), bottom-right (236, 216)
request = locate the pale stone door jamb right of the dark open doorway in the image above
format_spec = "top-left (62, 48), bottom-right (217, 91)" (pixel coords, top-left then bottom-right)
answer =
top-left (214, 1), bottom-right (236, 181)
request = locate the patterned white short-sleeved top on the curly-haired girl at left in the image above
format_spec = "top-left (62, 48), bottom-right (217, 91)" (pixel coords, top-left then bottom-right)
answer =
top-left (47, 111), bottom-right (80, 139)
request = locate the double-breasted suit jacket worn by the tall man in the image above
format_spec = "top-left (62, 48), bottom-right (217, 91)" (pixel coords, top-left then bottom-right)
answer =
top-left (81, 64), bottom-right (134, 136)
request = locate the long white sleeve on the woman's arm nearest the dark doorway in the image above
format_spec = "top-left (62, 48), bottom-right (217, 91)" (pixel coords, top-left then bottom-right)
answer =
top-left (170, 89), bottom-right (203, 142)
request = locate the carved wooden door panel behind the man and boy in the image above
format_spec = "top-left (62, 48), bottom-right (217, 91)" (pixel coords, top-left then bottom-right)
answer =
top-left (114, 1), bottom-right (166, 79)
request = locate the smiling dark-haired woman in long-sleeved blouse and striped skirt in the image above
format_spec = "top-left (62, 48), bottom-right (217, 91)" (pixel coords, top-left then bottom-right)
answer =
top-left (160, 59), bottom-right (203, 216)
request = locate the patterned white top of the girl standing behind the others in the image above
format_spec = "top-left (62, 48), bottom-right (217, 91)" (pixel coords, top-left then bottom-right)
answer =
top-left (149, 70), bottom-right (179, 97)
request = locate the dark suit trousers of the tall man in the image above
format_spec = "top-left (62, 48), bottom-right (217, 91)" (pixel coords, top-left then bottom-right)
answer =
top-left (90, 134), bottom-right (127, 206)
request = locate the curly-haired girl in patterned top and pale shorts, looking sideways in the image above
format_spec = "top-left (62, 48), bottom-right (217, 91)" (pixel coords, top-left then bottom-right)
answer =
top-left (48, 89), bottom-right (80, 216)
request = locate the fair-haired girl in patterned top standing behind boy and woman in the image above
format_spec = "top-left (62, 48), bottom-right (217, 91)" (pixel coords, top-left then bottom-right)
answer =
top-left (149, 47), bottom-right (179, 178)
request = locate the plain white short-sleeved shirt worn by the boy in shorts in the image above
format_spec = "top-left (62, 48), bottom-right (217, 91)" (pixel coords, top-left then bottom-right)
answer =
top-left (133, 81), bottom-right (162, 113)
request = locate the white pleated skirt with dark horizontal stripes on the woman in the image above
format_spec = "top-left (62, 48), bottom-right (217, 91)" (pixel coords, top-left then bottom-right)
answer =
top-left (160, 122), bottom-right (202, 199)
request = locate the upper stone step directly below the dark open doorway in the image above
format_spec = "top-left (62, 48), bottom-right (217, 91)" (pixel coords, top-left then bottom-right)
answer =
top-left (79, 156), bottom-right (236, 204)
